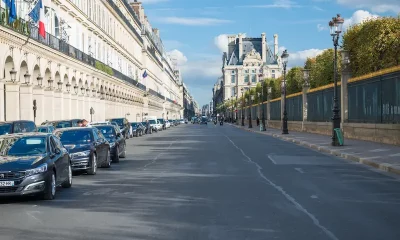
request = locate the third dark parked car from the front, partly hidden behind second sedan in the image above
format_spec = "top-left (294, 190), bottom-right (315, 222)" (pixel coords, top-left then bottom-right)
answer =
top-left (95, 125), bottom-right (126, 163)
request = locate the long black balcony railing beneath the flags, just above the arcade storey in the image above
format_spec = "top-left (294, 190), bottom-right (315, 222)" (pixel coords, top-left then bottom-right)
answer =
top-left (0, 8), bottom-right (146, 91)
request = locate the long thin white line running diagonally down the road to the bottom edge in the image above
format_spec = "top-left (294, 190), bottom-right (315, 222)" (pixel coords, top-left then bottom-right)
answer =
top-left (225, 135), bottom-right (339, 240)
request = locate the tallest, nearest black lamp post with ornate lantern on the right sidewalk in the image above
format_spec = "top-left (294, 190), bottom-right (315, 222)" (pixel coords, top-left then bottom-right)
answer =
top-left (329, 14), bottom-right (344, 146)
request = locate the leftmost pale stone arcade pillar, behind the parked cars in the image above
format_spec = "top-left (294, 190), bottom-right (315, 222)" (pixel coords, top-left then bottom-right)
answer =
top-left (5, 82), bottom-right (20, 121)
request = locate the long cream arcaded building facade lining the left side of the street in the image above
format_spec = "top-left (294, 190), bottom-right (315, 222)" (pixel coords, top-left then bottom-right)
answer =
top-left (0, 0), bottom-right (188, 124)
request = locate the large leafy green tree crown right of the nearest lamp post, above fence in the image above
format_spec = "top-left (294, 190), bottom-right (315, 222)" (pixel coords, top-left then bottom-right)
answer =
top-left (343, 15), bottom-right (400, 76)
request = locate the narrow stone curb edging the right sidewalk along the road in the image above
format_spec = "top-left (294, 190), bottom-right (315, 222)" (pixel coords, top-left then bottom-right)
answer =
top-left (228, 123), bottom-right (400, 175)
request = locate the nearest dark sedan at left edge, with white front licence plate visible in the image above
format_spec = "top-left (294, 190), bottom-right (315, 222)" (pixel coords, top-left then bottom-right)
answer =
top-left (0, 133), bottom-right (72, 200)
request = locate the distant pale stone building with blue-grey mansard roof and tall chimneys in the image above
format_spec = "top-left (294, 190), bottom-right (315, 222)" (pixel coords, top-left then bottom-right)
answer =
top-left (222, 33), bottom-right (282, 100)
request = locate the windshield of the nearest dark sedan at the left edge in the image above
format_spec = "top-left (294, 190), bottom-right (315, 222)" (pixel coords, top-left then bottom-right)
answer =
top-left (0, 136), bottom-right (46, 156)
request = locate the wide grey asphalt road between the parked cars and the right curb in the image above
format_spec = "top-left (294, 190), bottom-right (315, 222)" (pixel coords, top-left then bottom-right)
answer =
top-left (0, 124), bottom-right (400, 240)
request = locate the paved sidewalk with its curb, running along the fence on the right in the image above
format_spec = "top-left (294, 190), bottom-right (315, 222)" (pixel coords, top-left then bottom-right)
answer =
top-left (229, 124), bottom-right (400, 175)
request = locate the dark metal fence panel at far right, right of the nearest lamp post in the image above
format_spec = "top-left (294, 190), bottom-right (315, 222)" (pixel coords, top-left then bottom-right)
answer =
top-left (348, 72), bottom-right (400, 124)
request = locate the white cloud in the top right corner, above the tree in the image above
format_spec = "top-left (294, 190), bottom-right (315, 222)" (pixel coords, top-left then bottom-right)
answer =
top-left (337, 0), bottom-right (400, 14)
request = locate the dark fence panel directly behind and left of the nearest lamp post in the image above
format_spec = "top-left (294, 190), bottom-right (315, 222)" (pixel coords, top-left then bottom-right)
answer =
top-left (307, 88), bottom-right (340, 122)
